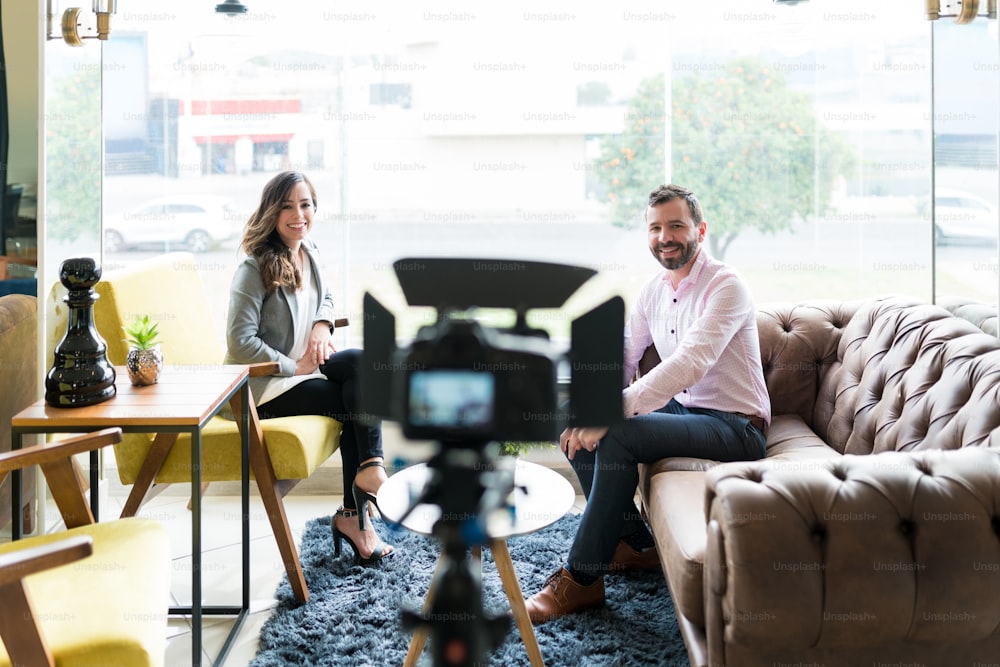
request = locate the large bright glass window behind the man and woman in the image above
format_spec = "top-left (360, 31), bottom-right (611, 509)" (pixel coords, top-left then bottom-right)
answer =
top-left (78, 0), bottom-right (998, 345)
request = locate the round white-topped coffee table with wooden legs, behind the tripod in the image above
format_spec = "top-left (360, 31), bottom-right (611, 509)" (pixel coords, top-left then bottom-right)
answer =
top-left (378, 459), bottom-right (576, 667)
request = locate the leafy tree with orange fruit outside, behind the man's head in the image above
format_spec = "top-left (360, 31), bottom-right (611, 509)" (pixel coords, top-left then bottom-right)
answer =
top-left (594, 58), bottom-right (853, 259)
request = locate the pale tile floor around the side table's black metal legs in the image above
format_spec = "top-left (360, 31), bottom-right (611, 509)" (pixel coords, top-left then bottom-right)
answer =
top-left (91, 452), bottom-right (583, 667)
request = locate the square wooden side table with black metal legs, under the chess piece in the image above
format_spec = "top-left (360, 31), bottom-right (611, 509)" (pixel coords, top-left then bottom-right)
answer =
top-left (11, 365), bottom-right (250, 665)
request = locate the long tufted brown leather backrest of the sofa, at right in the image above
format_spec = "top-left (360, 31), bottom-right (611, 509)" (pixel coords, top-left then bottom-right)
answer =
top-left (812, 297), bottom-right (1000, 454)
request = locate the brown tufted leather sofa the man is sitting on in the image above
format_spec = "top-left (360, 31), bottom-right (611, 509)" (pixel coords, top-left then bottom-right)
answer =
top-left (640, 297), bottom-right (1000, 667)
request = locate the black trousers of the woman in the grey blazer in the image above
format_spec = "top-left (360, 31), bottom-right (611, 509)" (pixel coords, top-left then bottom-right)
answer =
top-left (257, 349), bottom-right (382, 509)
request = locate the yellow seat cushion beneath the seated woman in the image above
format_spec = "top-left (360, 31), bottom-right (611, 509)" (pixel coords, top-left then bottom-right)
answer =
top-left (114, 415), bottom-right (342, 484)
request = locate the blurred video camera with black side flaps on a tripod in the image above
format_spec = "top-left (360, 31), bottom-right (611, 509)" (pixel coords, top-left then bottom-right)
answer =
top-left (359, 258), bottom-right (625, 667)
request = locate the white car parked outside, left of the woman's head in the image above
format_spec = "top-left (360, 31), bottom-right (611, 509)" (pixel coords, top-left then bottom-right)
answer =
top-left (104, 195), bottom-right (248, 252)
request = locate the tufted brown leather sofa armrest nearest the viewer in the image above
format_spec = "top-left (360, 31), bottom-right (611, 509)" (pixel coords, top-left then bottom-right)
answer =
top-left (704, 447), bottom-right (1000, 664)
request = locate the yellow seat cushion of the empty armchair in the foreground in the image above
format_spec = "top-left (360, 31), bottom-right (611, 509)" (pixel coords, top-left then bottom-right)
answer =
top-left (0, 519), bottom-right (171, 667)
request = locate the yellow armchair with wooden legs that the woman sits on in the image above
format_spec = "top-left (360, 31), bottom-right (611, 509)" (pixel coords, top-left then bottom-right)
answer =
top-left (52, 252), bottom-right (346, 602)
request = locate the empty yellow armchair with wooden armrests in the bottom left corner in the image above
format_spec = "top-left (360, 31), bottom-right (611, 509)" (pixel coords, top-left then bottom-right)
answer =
top-left (0, 428), bottom-right (171, 667)
